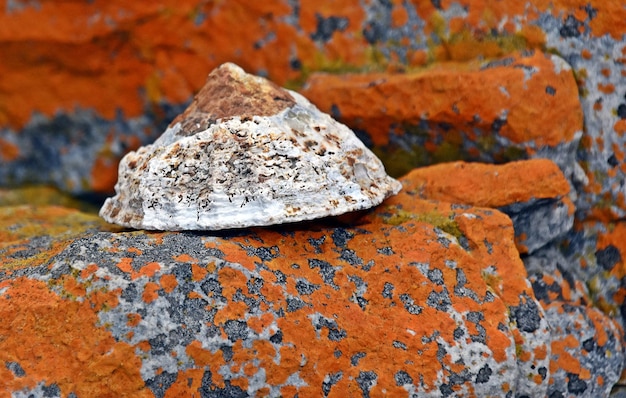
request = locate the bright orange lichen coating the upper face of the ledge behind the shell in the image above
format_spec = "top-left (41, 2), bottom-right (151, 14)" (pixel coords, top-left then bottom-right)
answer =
top-left (303, 51), bottom-right (582, 146)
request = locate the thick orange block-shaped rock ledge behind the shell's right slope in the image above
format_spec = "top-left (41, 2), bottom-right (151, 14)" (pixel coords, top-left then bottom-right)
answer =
top-left (302, 51), bottom-right (583, 183)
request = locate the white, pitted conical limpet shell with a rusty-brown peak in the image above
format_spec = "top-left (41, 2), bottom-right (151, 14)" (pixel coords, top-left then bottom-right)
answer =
top-left (100, 64), bottom-right (401, 230)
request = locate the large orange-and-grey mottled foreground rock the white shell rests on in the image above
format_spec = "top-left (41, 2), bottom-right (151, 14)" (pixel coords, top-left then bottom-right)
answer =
top-left (0, 161), bottom-right (623, 397)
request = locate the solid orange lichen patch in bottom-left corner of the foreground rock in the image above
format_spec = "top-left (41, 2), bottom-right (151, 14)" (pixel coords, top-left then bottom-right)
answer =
top-left (0, 279), bottom-right (152, 397)
